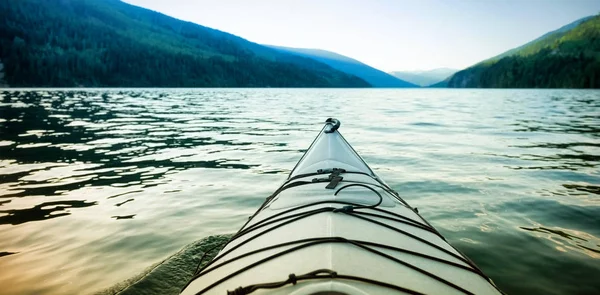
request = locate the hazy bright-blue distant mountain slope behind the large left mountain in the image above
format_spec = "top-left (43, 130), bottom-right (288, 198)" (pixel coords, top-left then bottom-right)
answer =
top-left (265, 45), bottom-right (417, 87)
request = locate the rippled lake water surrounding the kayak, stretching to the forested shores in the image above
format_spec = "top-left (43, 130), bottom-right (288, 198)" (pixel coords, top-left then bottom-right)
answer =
top-left (0, 89), bottom-right (600, 294)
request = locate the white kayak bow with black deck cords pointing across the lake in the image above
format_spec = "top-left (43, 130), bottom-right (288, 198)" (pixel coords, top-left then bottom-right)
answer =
top-left (182, 118), bottom-right (503, 295)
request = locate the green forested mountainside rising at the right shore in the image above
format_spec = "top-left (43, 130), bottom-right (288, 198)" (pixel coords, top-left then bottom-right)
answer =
top-left (446, 15), bottom-right (600, 88)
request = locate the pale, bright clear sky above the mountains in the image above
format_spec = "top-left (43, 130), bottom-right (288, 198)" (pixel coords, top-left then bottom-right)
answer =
top-left (124, 0), bottom-right (600, 72)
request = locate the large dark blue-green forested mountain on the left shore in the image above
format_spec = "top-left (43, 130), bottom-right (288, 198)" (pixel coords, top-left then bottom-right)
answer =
top-left (0, 0), bottom-right (370, 87)
